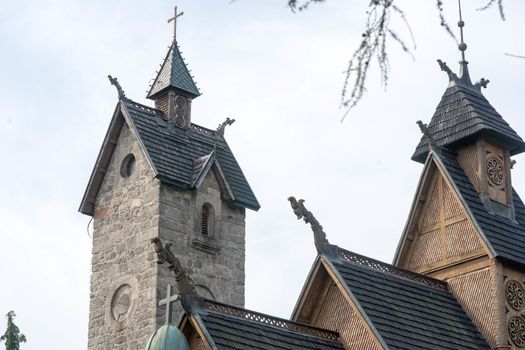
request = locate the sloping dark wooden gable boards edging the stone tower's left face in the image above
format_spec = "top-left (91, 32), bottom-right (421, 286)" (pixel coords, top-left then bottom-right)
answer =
top-left (78, 100), bottom-right (157, 216)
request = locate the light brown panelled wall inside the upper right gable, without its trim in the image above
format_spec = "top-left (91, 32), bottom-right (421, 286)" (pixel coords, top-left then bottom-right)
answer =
top-left (404, 171), bottom-right (485, 273)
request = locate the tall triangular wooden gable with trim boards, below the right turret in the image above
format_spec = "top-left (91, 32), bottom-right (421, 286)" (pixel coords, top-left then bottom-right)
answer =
top-left (394, 153), bottom-right (495, 273)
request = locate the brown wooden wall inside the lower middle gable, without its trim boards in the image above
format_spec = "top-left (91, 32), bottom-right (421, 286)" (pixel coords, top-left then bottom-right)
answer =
top-left (311, 283), bottom-right (383, 350)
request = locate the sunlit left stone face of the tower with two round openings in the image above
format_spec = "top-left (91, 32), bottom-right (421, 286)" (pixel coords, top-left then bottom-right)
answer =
top-left (88, 124), bottom-right (160, 349)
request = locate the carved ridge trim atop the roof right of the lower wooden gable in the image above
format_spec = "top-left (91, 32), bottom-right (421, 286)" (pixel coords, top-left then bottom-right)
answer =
top-left (335, 247), bottom-right (448, 292)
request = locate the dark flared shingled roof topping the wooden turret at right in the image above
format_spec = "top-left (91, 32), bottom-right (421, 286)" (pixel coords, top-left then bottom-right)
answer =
top-left (412, 62), bottom-right (525, 163)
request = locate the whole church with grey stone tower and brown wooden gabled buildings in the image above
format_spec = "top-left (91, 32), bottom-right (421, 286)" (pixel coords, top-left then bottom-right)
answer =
top-left (79, 8), bottom-right (525, 350)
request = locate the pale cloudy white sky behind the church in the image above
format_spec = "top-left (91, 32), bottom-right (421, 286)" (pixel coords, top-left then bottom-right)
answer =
top-left (0, 0), bottom-right (525, 350)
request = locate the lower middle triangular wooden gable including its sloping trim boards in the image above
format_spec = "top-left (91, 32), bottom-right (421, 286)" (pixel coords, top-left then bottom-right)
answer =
top-left (291, 256), bottom-right (387, 350)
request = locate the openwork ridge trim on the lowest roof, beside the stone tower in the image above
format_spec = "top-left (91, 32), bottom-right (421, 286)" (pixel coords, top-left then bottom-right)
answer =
top-left (202, 299), bottom-right (340, 342)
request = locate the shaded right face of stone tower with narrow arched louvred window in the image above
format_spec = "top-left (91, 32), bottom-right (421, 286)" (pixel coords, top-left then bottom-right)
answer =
top-left (157, 172), bottom-right (245, 322)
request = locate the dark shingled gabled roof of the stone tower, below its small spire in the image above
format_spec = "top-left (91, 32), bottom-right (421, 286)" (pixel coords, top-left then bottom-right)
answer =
top-left (80, 98), bottom-right (260, 215)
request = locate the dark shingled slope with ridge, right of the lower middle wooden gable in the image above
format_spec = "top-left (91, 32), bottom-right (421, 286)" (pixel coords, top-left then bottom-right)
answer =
top-left (325, 247), bottom-right (490, 350)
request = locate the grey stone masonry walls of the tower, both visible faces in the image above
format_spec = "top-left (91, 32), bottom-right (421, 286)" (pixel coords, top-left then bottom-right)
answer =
top-left (88, 124), bottom-right (245, 350)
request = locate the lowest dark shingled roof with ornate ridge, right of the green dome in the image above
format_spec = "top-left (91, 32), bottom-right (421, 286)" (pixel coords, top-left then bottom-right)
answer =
top-left (193, 300), bottom-right (344, 350)
